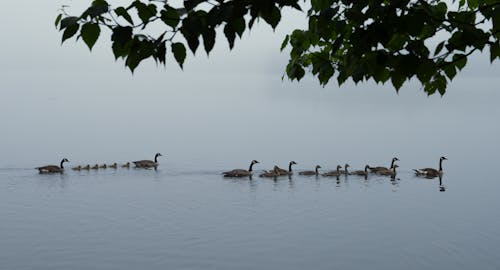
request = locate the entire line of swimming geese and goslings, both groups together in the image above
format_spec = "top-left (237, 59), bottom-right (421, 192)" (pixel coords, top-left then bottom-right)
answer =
top-left (36, 153), bottom-right (446, 179)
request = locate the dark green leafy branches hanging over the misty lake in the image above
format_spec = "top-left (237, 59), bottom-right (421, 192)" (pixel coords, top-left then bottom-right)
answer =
top-left (55, 0), bottom-right (500, 95)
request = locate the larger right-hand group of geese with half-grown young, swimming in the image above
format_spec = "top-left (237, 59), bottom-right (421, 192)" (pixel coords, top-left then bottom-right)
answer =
top-left (222, 157), bottom-right (446, 179)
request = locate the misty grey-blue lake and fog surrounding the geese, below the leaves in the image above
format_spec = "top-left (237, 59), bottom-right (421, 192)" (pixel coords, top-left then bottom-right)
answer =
top-left (0, 1), bottom-right (500, 270)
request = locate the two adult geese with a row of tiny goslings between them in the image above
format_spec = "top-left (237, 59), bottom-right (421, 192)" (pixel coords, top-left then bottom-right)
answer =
top-left (35, 153), bottom-right (162, 173)
